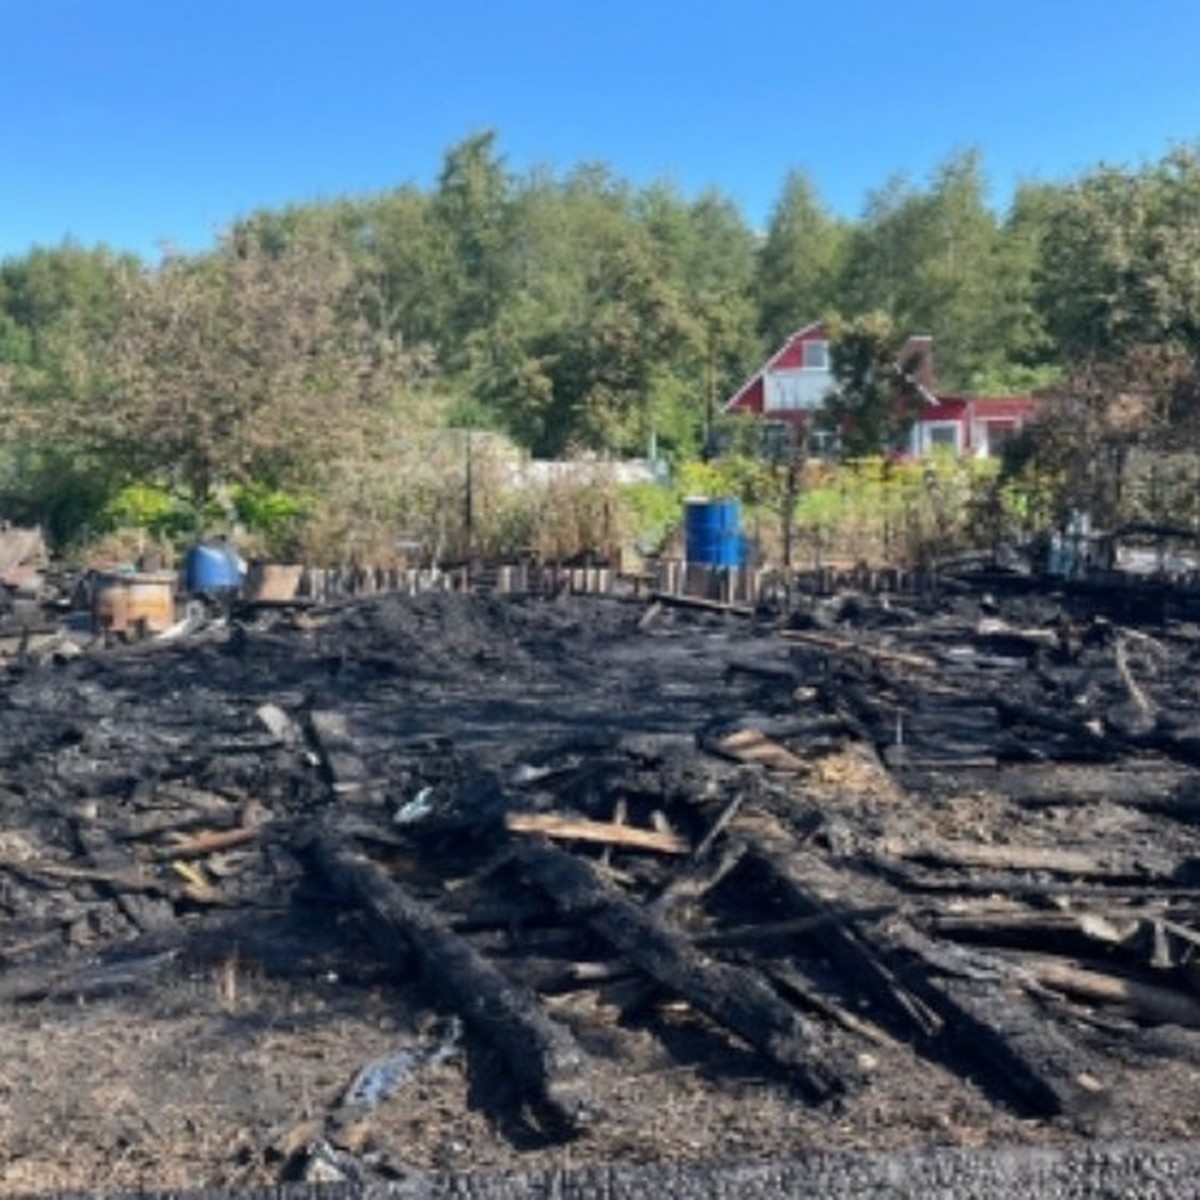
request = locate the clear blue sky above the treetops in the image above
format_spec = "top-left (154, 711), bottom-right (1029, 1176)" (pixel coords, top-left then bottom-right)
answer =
top-left (7, 0), bottom-right (1200, 257)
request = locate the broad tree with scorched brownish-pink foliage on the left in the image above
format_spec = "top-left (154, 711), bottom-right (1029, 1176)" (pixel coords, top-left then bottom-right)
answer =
top-left (12, 230), bottom-right (427, 512)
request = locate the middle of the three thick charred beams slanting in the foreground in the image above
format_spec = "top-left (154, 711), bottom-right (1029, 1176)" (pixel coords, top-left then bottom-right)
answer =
top-left (518, 845), bottom-right (860, 1098)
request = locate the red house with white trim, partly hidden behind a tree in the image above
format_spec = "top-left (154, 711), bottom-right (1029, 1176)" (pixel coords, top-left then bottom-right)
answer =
top-left (725, 320), bottom-right (1036, 458)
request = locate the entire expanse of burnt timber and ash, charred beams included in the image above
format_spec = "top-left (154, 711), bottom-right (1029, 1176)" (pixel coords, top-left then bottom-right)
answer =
top-left (0, 582), bottom-right (1200, 1194)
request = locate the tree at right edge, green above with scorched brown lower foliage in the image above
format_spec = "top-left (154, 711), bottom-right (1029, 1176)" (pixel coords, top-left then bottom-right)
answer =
top-left (1026, 148), bottom-right (1200, 524)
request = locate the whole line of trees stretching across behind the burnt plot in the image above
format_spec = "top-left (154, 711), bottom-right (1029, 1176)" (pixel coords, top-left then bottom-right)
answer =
top-left (0, 132), bottom-right (1200, 554)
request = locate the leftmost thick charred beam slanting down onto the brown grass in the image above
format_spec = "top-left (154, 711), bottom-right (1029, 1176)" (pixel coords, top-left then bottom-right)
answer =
top-left (311, 830), bottom-right (596, 1127)
